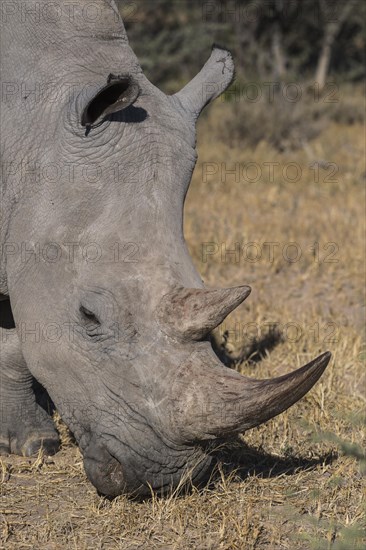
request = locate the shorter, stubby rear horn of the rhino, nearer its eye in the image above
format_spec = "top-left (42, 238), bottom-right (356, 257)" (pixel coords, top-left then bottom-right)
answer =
top-left (157, 286), bottom-right (251, 340)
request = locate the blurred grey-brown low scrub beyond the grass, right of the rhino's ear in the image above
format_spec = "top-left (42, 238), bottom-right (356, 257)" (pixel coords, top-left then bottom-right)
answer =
top-left (217, 82), bottom-right (365, 151)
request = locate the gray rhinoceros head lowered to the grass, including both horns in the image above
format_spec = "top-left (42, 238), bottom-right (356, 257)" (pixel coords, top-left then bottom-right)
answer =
top-left (9, 3), bottom-right (329, 496)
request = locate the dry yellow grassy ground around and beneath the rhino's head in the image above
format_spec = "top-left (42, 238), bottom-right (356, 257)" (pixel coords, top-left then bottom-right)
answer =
top-left (0, 87), bottom-right (366, 550)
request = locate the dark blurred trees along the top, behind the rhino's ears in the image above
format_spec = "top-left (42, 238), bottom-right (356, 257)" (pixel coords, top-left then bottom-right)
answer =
top-left (123, 0), bottom-right (366, 88)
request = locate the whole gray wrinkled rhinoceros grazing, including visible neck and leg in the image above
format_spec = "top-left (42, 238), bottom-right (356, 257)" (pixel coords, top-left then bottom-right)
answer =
top-left (0, 0), bottom-right (329, 496)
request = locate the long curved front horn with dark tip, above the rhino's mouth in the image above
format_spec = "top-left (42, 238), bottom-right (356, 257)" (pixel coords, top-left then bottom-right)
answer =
top-left (174, 352), bottom-right (331, 442)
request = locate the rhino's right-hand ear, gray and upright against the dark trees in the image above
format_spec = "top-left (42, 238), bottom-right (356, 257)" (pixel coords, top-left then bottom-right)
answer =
top-left (172, 46), bottom-right (234, 119)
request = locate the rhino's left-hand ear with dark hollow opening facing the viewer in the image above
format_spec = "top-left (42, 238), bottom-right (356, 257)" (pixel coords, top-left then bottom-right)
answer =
top-left (81, 74), bottom-right (140, 132)
